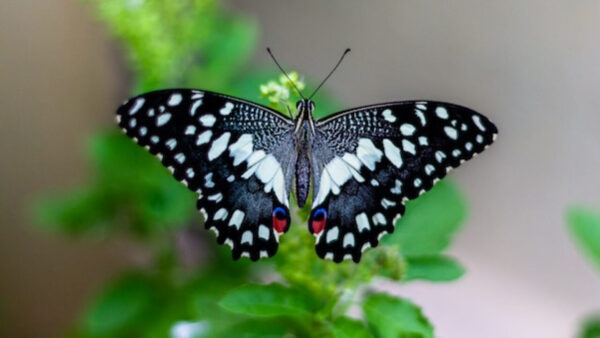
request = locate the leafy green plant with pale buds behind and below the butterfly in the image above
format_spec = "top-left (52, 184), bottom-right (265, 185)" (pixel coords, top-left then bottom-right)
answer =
top-left (37, 0), bottom-right (466, 337)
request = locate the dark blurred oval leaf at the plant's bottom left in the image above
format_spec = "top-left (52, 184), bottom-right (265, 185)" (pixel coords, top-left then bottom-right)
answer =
top-left (82, 275), bottom-right (156, 336)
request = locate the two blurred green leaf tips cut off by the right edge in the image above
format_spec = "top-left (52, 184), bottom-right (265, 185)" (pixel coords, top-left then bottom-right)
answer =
top-left (567, 206), bottom-right (600, 338)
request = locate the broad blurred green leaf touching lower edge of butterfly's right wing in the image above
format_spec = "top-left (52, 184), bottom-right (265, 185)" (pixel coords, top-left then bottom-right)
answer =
top-left (383, 181), bottom-right (466, 256)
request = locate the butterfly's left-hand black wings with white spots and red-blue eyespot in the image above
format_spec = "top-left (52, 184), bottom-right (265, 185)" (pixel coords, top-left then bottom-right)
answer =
top-left (117, 89), bottom-right (295, 260)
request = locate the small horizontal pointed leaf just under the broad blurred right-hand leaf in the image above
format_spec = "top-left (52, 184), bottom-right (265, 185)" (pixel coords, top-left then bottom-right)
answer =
top-left (404, 255), bottom-right (465, 282)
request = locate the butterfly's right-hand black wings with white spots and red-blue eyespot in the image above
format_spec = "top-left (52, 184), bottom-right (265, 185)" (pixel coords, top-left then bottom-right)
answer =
top-left (309, 101), bottom-right (497, 262)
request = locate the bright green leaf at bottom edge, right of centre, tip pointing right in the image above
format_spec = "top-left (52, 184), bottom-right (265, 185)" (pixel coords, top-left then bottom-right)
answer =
top-left (363, 293), bottom-right (433, 338)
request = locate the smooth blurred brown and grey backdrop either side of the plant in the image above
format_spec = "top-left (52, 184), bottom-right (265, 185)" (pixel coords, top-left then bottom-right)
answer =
top-left (0, 0), bottom-right (600, 337)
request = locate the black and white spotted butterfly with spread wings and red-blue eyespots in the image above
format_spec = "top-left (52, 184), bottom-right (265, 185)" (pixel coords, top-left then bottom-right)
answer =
top-left (117, 48), bottom-right (497, 262)
